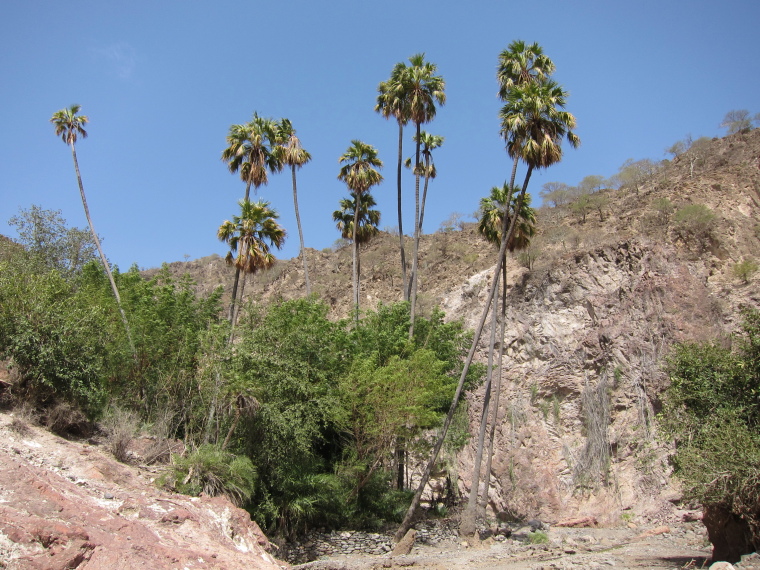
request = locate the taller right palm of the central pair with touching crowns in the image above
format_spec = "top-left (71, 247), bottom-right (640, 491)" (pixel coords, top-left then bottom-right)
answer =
top-left (408, 53), bottom-right (446, 338)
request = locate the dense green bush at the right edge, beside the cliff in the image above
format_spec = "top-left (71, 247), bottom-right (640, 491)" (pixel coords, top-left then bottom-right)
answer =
top-left (660, 310), bottom-right (760, 537)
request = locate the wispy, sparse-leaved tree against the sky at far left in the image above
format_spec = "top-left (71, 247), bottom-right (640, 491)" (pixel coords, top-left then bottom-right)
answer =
top-left (8, 204), bottom-right (97, 278)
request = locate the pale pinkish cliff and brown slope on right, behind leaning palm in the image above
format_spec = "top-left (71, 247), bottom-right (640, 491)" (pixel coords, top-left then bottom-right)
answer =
top-left (443, 133), bottom-right (760, 524)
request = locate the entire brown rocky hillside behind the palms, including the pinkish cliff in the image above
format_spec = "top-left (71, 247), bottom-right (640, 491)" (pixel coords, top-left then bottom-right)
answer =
top-left (149, 130), bottom-right (760, 523)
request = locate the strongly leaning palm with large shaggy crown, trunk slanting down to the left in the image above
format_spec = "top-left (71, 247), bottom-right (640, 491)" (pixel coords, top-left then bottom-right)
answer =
top-left (394, 66), bottom-right (580, 540)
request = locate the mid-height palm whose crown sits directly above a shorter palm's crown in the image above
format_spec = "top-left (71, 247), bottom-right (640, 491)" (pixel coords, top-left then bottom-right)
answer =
top-left (338, 140), bottom-right (383, 320)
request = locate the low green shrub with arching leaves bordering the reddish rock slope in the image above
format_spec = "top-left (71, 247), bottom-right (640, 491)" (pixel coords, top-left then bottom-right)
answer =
top-left (162, 444), bottom-right (258, 506)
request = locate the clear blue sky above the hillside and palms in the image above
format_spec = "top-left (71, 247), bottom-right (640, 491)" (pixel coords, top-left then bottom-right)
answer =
top-left (0, 0), bottom-right (760, 271)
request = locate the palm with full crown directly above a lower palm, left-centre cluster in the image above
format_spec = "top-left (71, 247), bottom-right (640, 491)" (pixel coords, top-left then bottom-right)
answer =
top-left (222, 112), bottom-right (282, 322)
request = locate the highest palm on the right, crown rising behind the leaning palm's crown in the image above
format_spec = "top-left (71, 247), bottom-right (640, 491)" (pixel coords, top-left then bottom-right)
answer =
top-left (496, 40), bottom-right (555, 191)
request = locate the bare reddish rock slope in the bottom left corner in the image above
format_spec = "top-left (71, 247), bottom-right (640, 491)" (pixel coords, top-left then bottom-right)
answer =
top-left (0, 414), bottom-right (287, 570)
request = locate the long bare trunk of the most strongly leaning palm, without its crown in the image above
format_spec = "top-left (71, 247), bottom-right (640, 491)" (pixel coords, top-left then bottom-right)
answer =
top-left (393, 166), bottom-right (533, 542)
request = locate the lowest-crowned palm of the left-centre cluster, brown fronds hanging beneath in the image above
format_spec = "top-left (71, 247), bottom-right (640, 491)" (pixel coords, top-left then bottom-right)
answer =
top-left (217, 199), bottom-right (285, 332)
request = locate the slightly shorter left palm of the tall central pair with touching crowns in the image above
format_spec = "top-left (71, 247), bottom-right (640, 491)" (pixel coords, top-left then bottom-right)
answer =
top-left (375, 62), bottom-right (409, 301)
